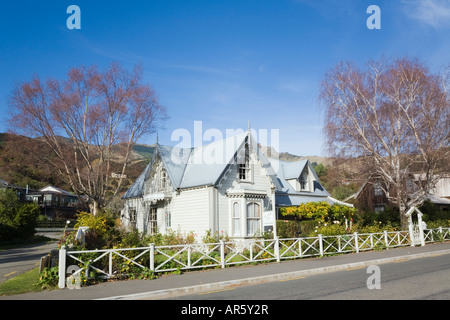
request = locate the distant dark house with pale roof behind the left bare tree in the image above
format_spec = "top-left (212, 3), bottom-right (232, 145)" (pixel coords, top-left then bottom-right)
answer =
top-left (26, 186), bottom-right (85, 219)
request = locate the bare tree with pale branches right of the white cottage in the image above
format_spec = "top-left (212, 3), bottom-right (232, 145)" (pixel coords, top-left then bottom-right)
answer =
top-left (320, 58), bottom-right (450, 227)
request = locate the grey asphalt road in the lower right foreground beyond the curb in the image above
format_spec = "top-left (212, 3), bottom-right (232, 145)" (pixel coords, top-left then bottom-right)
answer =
top-left (171, 253), bottom-right (450, 300)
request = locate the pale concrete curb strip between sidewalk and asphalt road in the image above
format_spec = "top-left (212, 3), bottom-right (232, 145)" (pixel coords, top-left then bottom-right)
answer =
top-left (97, 249), bottom-right (450, 300)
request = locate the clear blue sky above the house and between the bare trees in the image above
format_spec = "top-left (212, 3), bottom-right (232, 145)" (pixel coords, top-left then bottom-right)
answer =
top-left (0, 0), bottom-right (450, 155)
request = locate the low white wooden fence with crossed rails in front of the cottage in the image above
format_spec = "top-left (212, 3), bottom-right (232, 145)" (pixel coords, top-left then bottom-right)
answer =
top-left (59, 228), bottom-right (450, 288)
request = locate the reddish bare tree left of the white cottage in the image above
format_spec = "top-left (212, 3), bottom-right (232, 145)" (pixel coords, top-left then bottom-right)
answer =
top-left (9, 63), bottom-right (167, 214)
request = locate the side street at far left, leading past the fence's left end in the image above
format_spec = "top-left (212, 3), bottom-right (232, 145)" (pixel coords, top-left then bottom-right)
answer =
top-left (0, 242), bottom-right (57, 283)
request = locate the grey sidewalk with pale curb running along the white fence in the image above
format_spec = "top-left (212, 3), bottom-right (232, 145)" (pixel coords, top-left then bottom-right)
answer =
top-left (0, 242), bottom-right (450, 300)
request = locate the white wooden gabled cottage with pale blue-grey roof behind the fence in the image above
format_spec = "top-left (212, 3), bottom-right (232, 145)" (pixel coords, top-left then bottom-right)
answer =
top-left (121, 130), bottom-right (350, 239)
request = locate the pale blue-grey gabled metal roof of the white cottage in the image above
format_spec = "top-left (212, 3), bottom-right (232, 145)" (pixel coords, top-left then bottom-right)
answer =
top-left (122, 131), bottom-right (348, 205)
